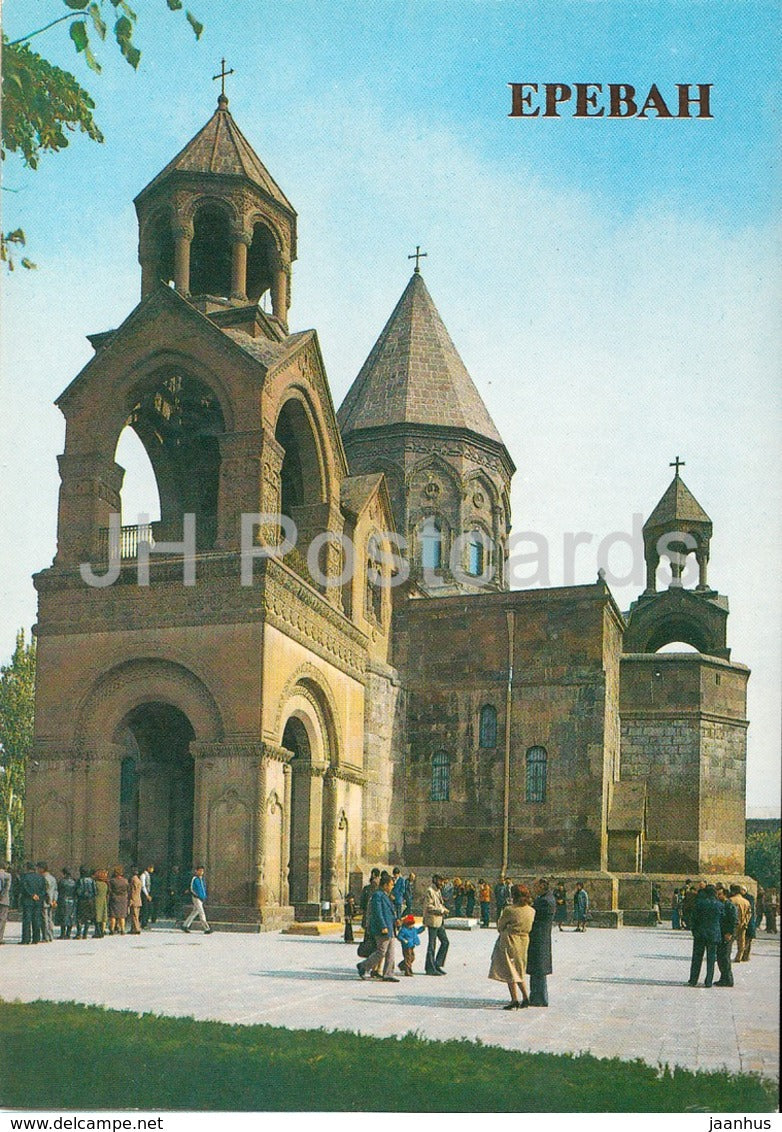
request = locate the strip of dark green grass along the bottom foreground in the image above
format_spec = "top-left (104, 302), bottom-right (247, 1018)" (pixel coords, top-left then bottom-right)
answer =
top-left (0, 1001), bottom-right (776, 1113)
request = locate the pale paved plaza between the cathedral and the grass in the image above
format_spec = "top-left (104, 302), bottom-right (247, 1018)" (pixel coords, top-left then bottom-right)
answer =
top-left (0, 924), bottom-right (780, 1078)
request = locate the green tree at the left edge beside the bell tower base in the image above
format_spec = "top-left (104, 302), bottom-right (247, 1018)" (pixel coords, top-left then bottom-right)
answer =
top-left (0, 629), bottom-right (35, 856)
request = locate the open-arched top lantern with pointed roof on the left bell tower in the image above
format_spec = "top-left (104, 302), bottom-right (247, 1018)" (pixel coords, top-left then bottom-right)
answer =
top-left (135, 92), bottom-right (297, 329)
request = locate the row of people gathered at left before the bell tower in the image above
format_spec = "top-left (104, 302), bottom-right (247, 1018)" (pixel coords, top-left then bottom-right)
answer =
top-left (0, 861), bottom-right (212, 944)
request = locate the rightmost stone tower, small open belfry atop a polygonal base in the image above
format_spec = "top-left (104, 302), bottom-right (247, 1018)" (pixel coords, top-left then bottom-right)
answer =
top-left (615, 456), bottom-right (749, 875)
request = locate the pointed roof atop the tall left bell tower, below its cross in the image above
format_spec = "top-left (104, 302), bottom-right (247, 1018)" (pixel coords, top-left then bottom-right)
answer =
top-left (136, 95), bottom-right (295, 216)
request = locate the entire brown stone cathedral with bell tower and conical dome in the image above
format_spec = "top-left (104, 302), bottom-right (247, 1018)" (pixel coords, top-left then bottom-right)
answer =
top-left (25, 94), bottom-right (749, 929)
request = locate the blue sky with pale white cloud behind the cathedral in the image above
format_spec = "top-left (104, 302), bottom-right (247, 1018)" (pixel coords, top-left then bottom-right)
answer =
top-left (0, 0), bottom-right (782, 805)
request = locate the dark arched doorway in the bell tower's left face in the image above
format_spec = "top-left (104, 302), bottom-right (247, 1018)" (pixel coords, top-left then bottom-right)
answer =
top-left (118, 703), bottom-right (195, 876)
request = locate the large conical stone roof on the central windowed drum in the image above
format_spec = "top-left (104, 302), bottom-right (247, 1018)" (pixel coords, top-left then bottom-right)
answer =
top-left (337, 271), bottom-right (504, 446)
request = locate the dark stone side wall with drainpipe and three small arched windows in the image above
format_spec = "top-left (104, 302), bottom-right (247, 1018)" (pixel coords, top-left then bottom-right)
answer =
top-left (399, 584), bottom-right (620, 873)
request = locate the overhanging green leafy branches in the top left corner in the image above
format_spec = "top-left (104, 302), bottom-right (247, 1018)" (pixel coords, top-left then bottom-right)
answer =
top-left (0, 0), bottom-right (203, 271)
